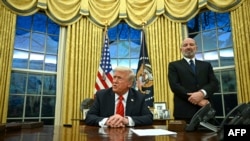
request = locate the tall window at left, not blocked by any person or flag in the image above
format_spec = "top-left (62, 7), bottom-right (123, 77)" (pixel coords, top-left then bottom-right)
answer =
top-left (7, 13), bottom-right (60, 125)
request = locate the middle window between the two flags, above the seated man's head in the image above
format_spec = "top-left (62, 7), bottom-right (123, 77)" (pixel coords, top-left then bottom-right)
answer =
top-left (108, 23), bottom-right (141, 73)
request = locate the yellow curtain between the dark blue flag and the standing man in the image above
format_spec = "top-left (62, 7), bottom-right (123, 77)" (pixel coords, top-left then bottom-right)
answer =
top-left (146, 16), bottom-right (182, 116)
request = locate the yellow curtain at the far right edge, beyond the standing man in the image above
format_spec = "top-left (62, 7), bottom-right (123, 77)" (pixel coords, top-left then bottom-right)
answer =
top-left (231, 0), bottom-right (250, 103)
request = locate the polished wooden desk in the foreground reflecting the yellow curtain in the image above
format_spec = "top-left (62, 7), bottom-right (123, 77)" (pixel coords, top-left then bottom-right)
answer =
top-left (0, 125), bottom-right (219, 141)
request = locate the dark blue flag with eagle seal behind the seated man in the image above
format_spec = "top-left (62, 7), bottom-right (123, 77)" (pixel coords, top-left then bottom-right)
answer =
top-left (136, 30), bottom-right (154, 107)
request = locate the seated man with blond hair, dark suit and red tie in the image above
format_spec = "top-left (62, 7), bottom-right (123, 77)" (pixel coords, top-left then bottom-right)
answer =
top-left (85, 66), bottom-right (153, 127)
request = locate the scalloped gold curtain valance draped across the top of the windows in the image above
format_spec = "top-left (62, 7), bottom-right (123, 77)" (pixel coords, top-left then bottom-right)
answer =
top-left (1, 0), bottom-right (244, 28)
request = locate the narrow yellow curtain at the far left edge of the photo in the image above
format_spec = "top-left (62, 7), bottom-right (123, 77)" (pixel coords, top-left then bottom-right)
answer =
top-left (0, 4), bottom-right (16, 123)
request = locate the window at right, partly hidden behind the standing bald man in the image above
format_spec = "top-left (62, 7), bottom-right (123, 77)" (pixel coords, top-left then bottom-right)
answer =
top-left (187, 11), bottom-right (237, 123)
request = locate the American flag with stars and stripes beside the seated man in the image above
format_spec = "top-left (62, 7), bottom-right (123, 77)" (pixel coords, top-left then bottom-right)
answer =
top-left (95, 31), bottom-right (113, 93)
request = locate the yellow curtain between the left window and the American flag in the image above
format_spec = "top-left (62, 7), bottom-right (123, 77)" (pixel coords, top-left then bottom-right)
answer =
top-left (61, 18), bottom-right (103, 124)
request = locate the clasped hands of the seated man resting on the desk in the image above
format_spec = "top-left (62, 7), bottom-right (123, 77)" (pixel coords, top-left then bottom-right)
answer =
top-left (106, 114), bottom-right (128, 127)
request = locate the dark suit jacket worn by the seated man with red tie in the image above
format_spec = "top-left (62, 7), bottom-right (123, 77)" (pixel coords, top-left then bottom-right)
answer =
top-left (85, 88), bottom-right (153, 126)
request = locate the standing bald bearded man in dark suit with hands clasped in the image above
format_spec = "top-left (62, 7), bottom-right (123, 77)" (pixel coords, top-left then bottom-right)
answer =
top-left (168, 38), bottom-right (219, 123)
